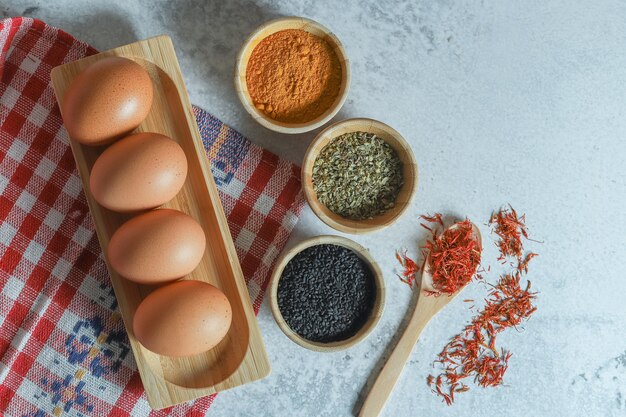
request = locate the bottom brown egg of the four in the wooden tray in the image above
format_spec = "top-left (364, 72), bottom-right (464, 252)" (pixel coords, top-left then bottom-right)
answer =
top-left (133, 281), bottom-right (232, 356)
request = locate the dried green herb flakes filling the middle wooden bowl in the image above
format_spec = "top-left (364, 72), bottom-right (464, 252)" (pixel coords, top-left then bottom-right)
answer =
top-left (313, 132), bottom-right (404, 220)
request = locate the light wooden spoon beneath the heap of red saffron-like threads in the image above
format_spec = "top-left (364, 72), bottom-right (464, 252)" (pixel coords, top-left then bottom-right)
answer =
top-left (359, 223), bottom-right (482, 417)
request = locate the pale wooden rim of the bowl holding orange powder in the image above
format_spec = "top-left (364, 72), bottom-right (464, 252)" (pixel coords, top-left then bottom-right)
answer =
top-left (233, 16), bottom-right (352, 134)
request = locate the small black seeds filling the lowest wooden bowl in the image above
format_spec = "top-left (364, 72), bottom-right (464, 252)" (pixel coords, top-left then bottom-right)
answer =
top-left (277, 244), bottom-right (376, 343)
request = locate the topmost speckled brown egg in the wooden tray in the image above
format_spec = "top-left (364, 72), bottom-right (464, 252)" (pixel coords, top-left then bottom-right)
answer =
top-left (61, 57), bottom-right (153, 145)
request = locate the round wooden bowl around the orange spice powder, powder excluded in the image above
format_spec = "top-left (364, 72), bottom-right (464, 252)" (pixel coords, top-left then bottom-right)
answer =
top-left (235, 17), bottom-right (350, 134)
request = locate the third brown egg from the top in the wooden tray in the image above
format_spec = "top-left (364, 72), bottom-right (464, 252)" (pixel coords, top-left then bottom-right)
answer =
top-left (107, 209), bottom-right (206, 284)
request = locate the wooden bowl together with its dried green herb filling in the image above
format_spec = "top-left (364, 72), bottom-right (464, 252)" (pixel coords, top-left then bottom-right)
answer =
top-left (302, 119), bottom-right (417, 233)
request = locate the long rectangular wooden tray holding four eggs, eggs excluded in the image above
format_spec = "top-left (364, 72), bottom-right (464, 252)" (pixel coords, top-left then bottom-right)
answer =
top-left (52, 36), bottom-right (270, 409)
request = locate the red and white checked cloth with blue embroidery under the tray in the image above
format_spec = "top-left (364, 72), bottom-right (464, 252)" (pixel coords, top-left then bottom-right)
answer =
top-left (0, 18), bottom-right (303, 417)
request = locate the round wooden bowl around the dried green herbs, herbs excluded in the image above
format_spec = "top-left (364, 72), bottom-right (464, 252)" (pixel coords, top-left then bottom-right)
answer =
top-left (301, 119), bottom-right (418, 234)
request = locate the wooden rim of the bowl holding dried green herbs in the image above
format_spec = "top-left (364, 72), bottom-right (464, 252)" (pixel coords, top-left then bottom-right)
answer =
top-left (300, 117), bottom-right (419, 234)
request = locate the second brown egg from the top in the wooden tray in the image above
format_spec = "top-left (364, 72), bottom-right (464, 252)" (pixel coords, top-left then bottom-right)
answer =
top-left (89, 133), bottom-right (187, 212)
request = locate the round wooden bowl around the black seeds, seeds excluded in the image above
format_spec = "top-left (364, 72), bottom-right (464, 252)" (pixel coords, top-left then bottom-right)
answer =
top-left (269, 235), bottom-right (385, 352)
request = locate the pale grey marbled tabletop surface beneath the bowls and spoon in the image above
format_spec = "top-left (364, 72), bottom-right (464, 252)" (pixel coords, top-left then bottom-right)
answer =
top-left (0, 0), bottom-right (626, 417)
